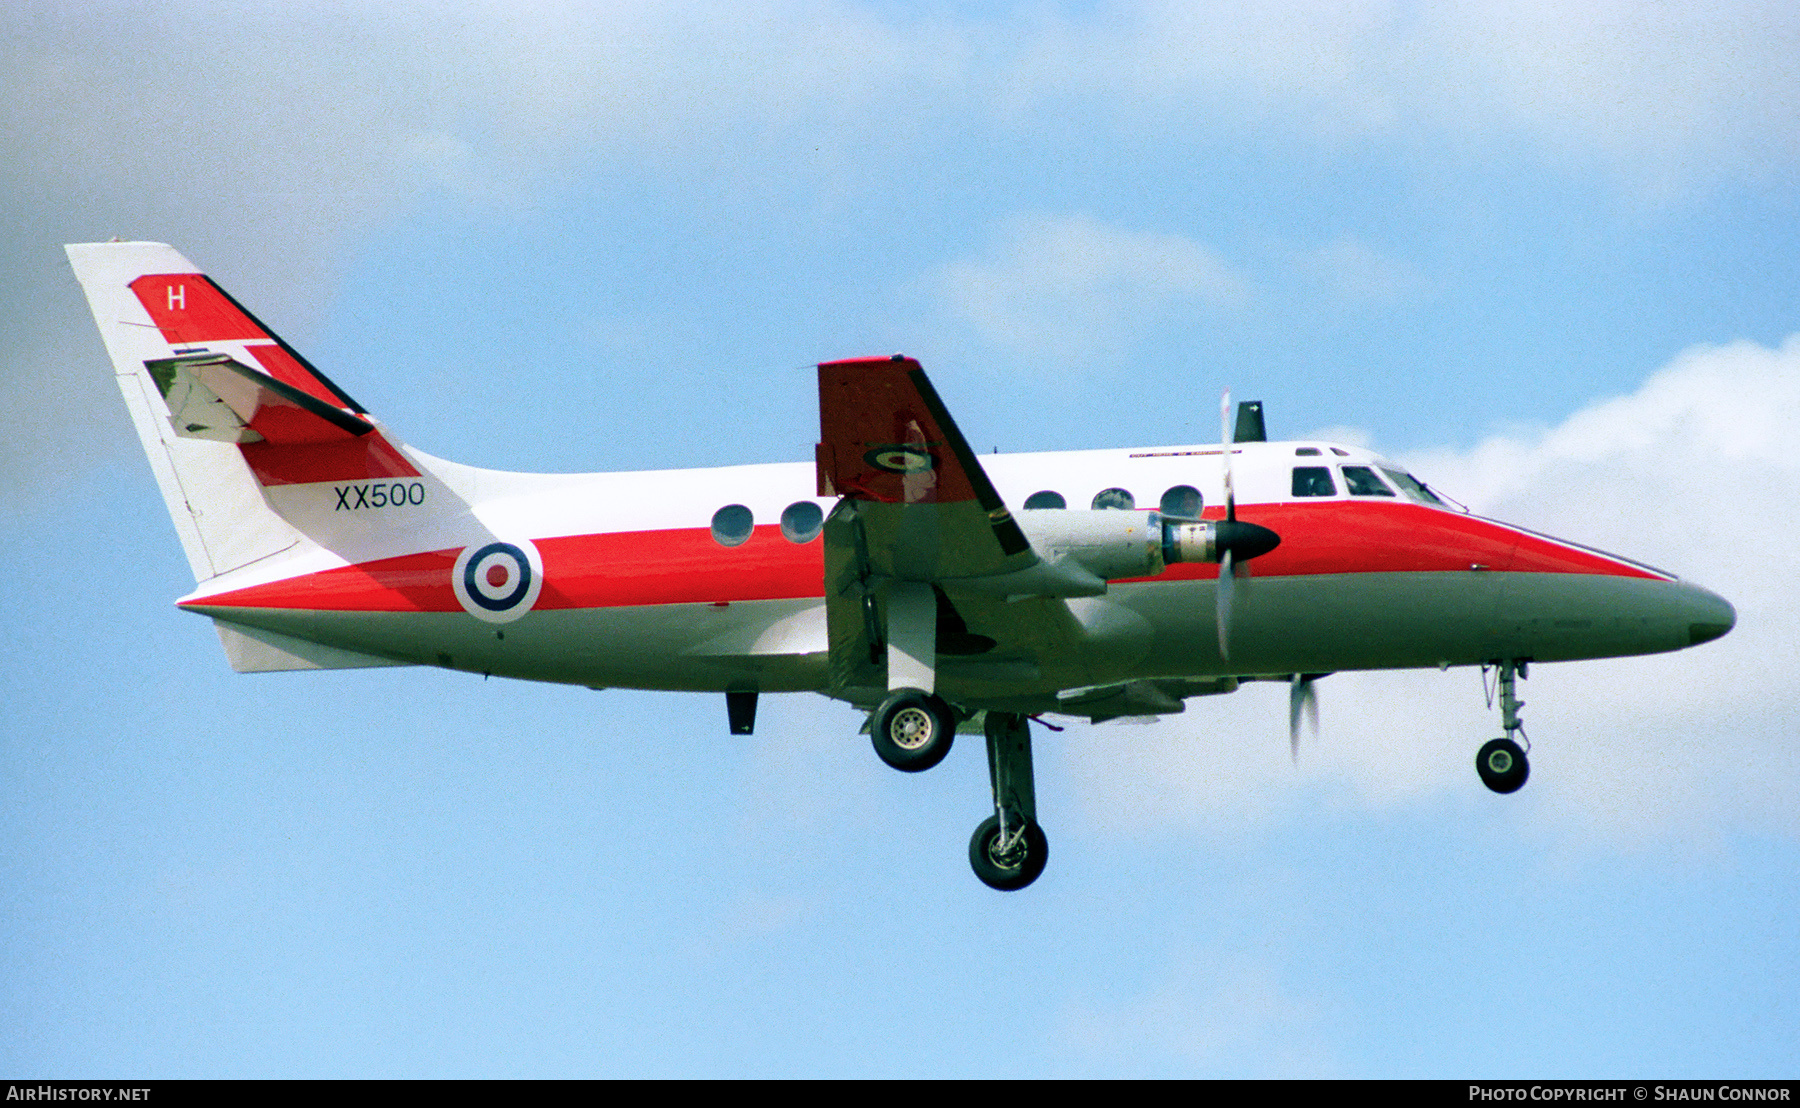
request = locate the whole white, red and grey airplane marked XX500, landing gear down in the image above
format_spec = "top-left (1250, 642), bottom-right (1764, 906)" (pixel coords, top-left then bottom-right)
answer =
top-left (67, 241), bottom-right (1737, 890)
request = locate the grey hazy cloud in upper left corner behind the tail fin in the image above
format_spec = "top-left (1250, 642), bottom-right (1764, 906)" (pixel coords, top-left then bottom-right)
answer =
top-left (0, 0), bottom-right (956, 496)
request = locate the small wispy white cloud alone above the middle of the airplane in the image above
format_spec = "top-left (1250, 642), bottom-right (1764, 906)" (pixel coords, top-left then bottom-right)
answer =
top-left (931, 216), bottom-right (1247, 360)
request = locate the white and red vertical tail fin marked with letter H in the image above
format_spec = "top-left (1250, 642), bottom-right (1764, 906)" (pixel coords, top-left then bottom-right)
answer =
top-left (67, 243), bottom-right (418, 583)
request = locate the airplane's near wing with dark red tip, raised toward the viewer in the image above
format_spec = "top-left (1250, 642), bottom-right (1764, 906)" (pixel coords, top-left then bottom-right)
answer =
top-left (817, 356), bottom-right (1105, 693)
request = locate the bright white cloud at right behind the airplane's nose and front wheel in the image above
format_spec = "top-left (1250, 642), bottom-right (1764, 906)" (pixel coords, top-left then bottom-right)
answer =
top-left (1069, 335), bottom-right (1800, 851)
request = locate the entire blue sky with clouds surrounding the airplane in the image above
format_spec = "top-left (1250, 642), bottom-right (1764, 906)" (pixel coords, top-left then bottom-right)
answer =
top-left (0, 0), bottom-right (1800, 1077)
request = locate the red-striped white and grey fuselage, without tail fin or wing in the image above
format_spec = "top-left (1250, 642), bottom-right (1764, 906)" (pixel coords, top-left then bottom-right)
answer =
top-left (180, 442), bottom-right (1733, 705)
